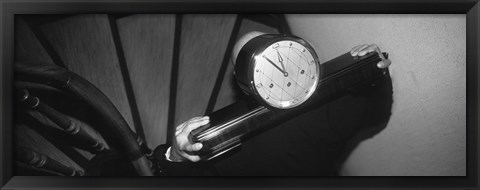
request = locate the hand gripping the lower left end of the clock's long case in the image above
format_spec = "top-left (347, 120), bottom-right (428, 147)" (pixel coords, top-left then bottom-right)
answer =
top-left (170, 116), bottom-right (210, 162)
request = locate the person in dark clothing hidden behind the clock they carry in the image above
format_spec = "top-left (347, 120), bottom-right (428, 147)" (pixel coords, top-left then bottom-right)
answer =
top-left (154, 32), bottom-right (393, 176)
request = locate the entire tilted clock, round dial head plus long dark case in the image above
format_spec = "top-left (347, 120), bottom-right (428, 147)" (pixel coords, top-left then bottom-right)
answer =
top-left (189, 34), bottom-right (390, 160)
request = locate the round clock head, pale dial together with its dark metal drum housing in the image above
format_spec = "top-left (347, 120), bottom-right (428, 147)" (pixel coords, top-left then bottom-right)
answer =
top-left (234, 34), bottom-right (322, 109)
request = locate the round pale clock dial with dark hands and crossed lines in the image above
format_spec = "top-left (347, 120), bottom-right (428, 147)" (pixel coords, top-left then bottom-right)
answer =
top-left (253, 40), bottom-right (320, 109)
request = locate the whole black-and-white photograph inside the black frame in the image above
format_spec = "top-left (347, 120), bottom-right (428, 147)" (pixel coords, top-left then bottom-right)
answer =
top-left (12, 13), bottom-right (467, 177)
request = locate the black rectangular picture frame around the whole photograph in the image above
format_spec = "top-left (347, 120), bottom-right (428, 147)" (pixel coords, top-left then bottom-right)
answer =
top-left (0, 0), bottom-right (480, 189)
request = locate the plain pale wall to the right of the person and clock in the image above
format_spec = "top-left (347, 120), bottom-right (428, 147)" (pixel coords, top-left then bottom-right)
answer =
top-left (287, 15), bottom-right (466, 176)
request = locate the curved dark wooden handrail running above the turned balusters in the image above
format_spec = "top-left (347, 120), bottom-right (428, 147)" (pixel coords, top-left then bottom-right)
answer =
top-left (14, 62), bottom-right (153, 176)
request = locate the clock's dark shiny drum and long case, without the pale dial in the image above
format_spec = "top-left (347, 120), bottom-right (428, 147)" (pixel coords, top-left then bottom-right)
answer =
top-left (188, 34), bottom-right (390, 160)
